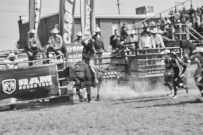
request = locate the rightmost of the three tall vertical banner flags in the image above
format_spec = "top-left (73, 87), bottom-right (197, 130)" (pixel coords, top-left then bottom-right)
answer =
top-left (80, 0), bottom-right (95, 38)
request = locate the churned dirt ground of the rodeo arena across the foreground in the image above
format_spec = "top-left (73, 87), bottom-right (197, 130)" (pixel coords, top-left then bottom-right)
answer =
top-left (0, 89), bottom-right (203, 135)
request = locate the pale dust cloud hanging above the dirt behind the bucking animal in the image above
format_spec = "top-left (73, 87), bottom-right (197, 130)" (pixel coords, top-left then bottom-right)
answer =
top-left (97, 79), bottom-right (167, 100)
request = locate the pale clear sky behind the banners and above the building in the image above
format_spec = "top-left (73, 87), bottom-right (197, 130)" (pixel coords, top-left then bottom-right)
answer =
top-left (0, 0), bottom-right (203, 51)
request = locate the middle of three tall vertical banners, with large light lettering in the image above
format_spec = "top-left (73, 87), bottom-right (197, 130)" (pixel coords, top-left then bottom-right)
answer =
top-left (59, 0), bottom-right (75, 44)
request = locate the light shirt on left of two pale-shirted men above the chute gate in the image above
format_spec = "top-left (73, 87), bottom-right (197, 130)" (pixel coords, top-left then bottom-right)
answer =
top-left (138, 35), bottom-right (155, 49)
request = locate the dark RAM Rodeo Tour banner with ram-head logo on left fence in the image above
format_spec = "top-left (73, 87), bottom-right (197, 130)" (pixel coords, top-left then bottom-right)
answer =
top-left (0, 65), bottom-right (58, 100)
